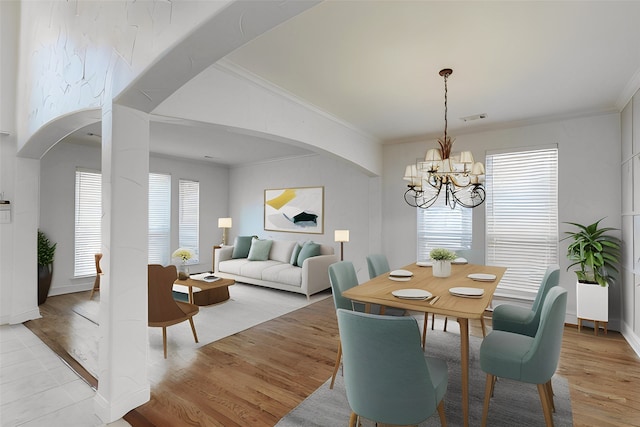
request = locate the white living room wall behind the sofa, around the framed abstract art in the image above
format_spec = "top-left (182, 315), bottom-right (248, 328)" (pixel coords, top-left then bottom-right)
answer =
top-left (229, 155), bottom-right (381, 282)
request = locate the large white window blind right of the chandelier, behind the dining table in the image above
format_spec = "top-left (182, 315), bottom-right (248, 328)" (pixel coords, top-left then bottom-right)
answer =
top-left (485, 146), bottom-right (558, 300)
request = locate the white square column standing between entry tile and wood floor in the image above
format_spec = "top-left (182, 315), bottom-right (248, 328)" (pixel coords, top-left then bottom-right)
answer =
top-left (95, 104), bottom-right (150, 423)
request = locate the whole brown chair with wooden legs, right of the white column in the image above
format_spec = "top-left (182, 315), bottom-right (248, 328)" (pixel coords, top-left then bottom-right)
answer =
top-left (148, 264), bottom-right (200, 359)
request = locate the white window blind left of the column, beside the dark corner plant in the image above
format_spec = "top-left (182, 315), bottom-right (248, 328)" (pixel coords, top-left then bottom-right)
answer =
top-left (73, 169), bottom-right (102, 277)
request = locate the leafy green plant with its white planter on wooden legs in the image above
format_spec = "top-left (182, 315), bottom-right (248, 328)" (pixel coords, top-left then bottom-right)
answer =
top-left (562, 218), bottom-right (621, 332)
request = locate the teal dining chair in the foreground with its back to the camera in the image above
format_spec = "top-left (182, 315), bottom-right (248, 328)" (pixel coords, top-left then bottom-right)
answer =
top-left (337, 309), bottom-right (448, 426)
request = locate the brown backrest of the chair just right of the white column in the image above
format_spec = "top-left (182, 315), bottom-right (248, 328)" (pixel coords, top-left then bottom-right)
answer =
top-left (148, 264), bottom-right (185, 323)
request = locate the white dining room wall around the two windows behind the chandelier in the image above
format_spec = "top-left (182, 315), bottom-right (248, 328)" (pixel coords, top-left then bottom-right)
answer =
top-left (382, 114), bottom-right (621, 329)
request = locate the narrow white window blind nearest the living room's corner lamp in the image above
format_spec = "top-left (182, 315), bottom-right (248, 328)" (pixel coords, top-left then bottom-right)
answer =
top-left (178, 179), bottom-right (200, 264)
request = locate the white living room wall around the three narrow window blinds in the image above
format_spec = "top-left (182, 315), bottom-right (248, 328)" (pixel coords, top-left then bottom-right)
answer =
top-left (40, 142), bottom-right (229, 295)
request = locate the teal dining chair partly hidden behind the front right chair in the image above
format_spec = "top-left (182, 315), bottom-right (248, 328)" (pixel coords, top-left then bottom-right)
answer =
top-left (492, 264), bottom-right (560, 337)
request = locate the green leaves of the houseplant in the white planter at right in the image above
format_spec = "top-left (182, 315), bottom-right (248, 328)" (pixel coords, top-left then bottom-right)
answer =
top-left (562, 218), bottom-right (621, 287)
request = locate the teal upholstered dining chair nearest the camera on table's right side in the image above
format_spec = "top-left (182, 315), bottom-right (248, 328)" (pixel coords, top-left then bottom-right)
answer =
top-left (478, 286), bottom-right (567, 427)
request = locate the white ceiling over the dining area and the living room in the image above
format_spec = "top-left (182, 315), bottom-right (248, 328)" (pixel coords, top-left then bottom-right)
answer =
top-left (66, 0), bottom-right (640, 165)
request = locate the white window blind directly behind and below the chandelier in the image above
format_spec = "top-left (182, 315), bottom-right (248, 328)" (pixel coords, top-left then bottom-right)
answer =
top-left (416, 196), bottom-right (473, 261)
